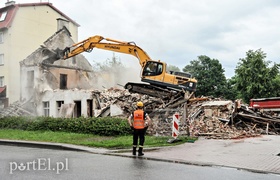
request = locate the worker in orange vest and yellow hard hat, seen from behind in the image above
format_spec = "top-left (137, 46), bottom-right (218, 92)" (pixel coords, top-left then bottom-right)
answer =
top-left (128, 101), bottom-right (151, 156)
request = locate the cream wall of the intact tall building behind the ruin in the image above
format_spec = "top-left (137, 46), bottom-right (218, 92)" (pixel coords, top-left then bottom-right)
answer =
top-left (0, 3), bottom-right (78, 103)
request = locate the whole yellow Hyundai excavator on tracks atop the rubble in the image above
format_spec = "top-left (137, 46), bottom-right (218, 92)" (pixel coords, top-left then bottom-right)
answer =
top-left (57, 35), bottom-right (197, 99)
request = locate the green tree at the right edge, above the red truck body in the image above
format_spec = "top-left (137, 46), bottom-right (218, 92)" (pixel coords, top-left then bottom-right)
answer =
top-left (235, 49), bottom-right (280, 103)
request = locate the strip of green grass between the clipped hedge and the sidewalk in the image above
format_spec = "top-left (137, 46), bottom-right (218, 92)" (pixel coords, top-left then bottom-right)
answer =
top-left (0, 129), bottom-right (197, 149)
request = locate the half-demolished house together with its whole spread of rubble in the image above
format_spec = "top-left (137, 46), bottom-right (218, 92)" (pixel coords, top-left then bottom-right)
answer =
top-left (0, 28), bottom-right (280, 139)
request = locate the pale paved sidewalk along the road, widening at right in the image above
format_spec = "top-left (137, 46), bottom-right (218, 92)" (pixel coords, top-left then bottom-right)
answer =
top-left (0, 135), bottom-right (280, 174)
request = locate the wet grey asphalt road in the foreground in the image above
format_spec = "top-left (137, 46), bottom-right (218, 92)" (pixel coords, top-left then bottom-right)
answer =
top-left (0, 145), bottom-right (280, 180)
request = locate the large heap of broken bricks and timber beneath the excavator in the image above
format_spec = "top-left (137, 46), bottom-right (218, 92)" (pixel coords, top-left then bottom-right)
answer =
top-left (95, 89), bottom-right (280, 139)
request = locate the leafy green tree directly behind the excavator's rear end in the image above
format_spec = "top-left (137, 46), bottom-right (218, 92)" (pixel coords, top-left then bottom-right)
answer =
top-left (183, 55), bottom-right (227, 97)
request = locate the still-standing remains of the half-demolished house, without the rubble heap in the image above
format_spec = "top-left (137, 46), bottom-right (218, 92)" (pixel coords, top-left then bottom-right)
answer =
top-left (20, 27), bottom-right (99, 117)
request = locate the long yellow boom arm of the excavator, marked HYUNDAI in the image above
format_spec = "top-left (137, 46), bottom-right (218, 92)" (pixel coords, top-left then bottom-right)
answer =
top-left (63, 36), bottom-right (151, 68)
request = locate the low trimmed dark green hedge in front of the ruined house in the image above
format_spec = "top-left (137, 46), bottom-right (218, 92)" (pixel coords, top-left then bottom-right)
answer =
top-left (0, 117), bottom-right (131, 136)
